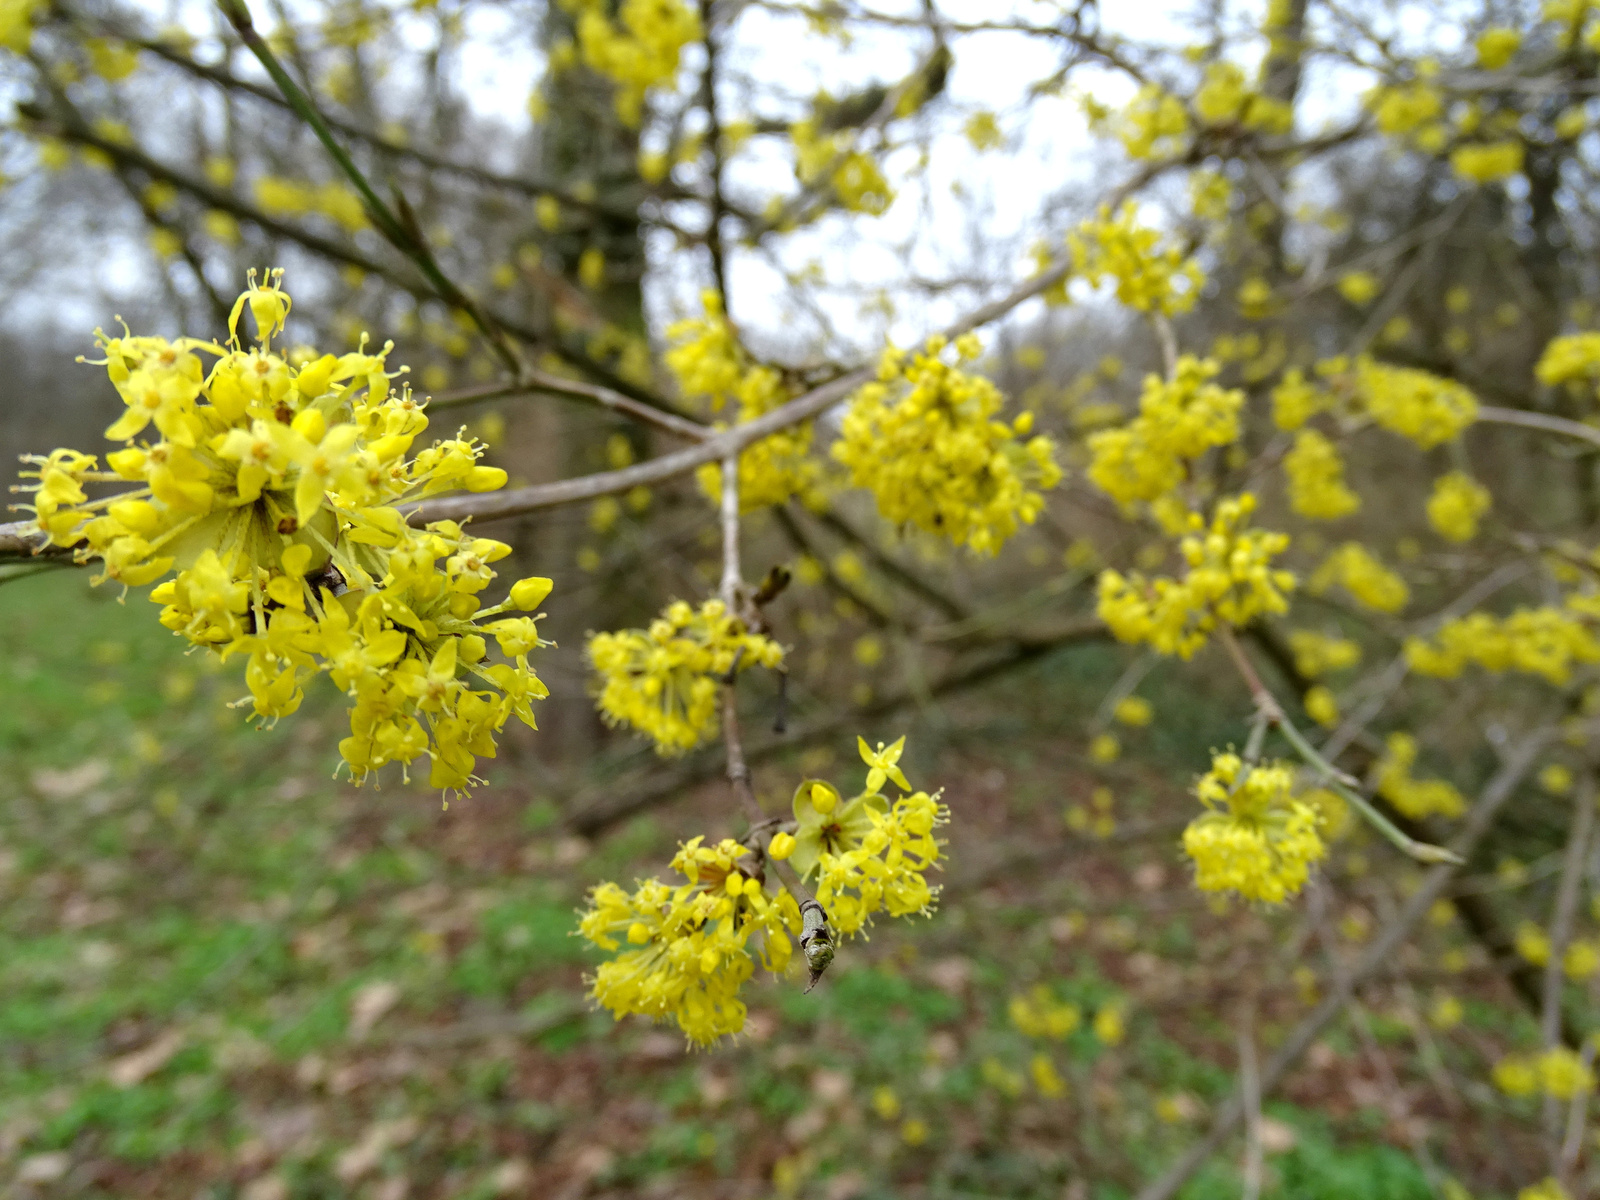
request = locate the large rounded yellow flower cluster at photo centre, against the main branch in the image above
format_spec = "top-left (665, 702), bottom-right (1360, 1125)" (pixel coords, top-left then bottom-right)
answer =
top-left (834, 334), bottom-right (1061, 554)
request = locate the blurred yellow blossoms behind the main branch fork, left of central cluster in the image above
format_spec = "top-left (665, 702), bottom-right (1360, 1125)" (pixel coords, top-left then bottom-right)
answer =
top-left (666, 299), bottom-right (822, 512)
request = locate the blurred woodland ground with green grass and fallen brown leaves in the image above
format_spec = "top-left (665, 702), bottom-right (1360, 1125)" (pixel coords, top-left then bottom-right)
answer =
top-left (0, 573), bottom-right (1544, 1200)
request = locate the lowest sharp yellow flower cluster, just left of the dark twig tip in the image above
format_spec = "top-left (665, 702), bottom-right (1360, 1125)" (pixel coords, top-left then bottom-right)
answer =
top-left (578, 837), bottom-right (800, 1046)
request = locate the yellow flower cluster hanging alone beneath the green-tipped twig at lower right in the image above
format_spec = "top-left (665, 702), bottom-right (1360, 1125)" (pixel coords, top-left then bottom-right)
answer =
top-left (1184, 754), bottom-right (1328, 904)
